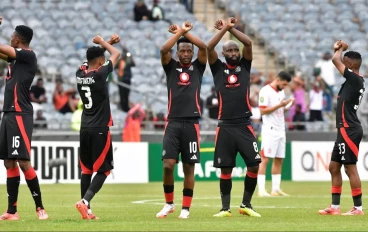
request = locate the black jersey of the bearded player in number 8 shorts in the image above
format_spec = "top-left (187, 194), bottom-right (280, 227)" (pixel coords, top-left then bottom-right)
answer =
top-left (210, 58), bottom-right (252, 120)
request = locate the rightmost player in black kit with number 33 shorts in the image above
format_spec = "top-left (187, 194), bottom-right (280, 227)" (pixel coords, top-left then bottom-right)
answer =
top-left (319, 40), bottom-right (365, 215)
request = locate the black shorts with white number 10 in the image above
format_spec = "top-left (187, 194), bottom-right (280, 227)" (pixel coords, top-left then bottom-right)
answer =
top-left (162, 120), bottom-right (200, 163)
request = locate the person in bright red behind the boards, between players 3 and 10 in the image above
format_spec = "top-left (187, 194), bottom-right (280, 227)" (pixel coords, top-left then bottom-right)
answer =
top-left (122, 104), bottom-right (145, 142)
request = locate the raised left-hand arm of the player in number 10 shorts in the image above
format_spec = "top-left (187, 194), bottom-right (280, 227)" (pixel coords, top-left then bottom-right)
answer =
top-left (160, 24), bottom-right (185, 65)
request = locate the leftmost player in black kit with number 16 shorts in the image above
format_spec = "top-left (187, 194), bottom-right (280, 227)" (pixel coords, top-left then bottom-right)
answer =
top-left (0, 25), bottom-right (48, 220)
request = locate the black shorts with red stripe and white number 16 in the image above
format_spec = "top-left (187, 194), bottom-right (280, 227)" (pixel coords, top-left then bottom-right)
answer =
top-left (0, 113), bottom-right (33, 160)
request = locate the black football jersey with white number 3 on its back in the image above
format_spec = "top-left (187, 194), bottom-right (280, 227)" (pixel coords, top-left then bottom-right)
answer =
top-left (76, 60), bottom-right (113, 128)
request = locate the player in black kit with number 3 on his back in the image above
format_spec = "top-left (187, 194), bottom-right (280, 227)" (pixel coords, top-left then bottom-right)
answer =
top-left (76, 35), bottom-right (120, 220)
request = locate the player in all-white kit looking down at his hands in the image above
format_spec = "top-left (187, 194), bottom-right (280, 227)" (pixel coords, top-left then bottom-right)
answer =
top-left (258, 71), bottom-right (294, 196)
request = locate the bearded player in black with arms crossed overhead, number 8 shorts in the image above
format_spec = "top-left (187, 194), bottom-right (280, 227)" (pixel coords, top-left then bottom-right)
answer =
top-left (207, 18), bottom-right (261, 217)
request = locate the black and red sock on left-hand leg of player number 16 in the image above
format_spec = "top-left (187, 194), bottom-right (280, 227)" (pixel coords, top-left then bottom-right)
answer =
top-left (6, 167), bottom-right (20, 214)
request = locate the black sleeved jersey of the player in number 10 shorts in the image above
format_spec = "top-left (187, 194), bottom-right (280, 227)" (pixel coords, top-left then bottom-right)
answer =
top-left (163, 59), bottom-right (206, 119)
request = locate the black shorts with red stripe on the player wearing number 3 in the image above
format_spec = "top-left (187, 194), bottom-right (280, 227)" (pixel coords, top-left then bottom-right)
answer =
top-left (79, 129), bottom-right (114, 174)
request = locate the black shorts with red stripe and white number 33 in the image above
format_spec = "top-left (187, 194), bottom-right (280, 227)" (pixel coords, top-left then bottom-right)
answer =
top-left (331, 127), bottom-right (363, 164)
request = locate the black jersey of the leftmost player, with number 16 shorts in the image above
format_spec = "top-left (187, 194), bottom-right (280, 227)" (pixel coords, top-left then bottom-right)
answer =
top-left (3, 48), bottom-right (37, 114)
